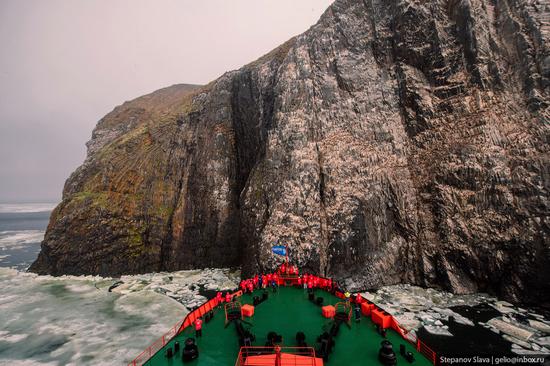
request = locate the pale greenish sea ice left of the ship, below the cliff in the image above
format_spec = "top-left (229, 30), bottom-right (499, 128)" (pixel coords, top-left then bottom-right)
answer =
top-left (0, 268), bottom-right (239, 366)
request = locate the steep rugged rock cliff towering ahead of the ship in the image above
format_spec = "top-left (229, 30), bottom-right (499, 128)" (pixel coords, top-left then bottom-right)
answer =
top-left (31, 0), bottom-right (550, 302)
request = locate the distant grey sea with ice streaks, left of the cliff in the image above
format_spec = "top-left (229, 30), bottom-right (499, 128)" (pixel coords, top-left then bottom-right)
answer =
top-left (0, 203), bottom-right (55, 271)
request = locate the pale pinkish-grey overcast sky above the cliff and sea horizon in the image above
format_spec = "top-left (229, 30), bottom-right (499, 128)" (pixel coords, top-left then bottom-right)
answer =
top-left (0, 0), bottom-right (332, 202)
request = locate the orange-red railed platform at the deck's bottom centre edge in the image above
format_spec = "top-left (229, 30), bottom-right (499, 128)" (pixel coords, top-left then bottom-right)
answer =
top-left (235, 346), bottom-right (323, 366)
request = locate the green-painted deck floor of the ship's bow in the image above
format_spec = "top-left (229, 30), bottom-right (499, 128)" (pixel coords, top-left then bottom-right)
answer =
top-left (145, 287), bottom-right (432, 366)
